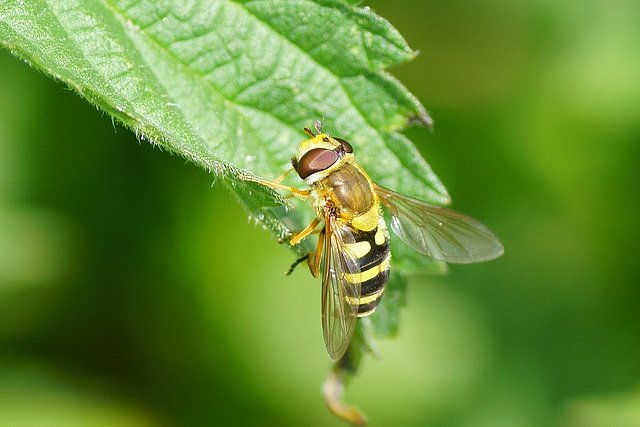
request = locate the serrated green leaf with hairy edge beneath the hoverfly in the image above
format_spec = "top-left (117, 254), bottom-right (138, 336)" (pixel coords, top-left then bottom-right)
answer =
top-left (0, 0), bottom-right (449, 422)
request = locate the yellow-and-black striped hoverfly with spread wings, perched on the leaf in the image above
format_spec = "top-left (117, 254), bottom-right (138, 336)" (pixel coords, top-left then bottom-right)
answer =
top-left (243, 121), bottom-right (504, 361)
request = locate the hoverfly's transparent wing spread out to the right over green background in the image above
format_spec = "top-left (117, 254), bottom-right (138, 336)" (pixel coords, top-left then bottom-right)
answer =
top-left (374, 184), bottom-right (504, 264)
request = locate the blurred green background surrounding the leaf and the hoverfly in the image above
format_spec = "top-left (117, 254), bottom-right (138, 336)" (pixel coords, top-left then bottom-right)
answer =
top-left (0, 0), bottom-right (640, 426)
